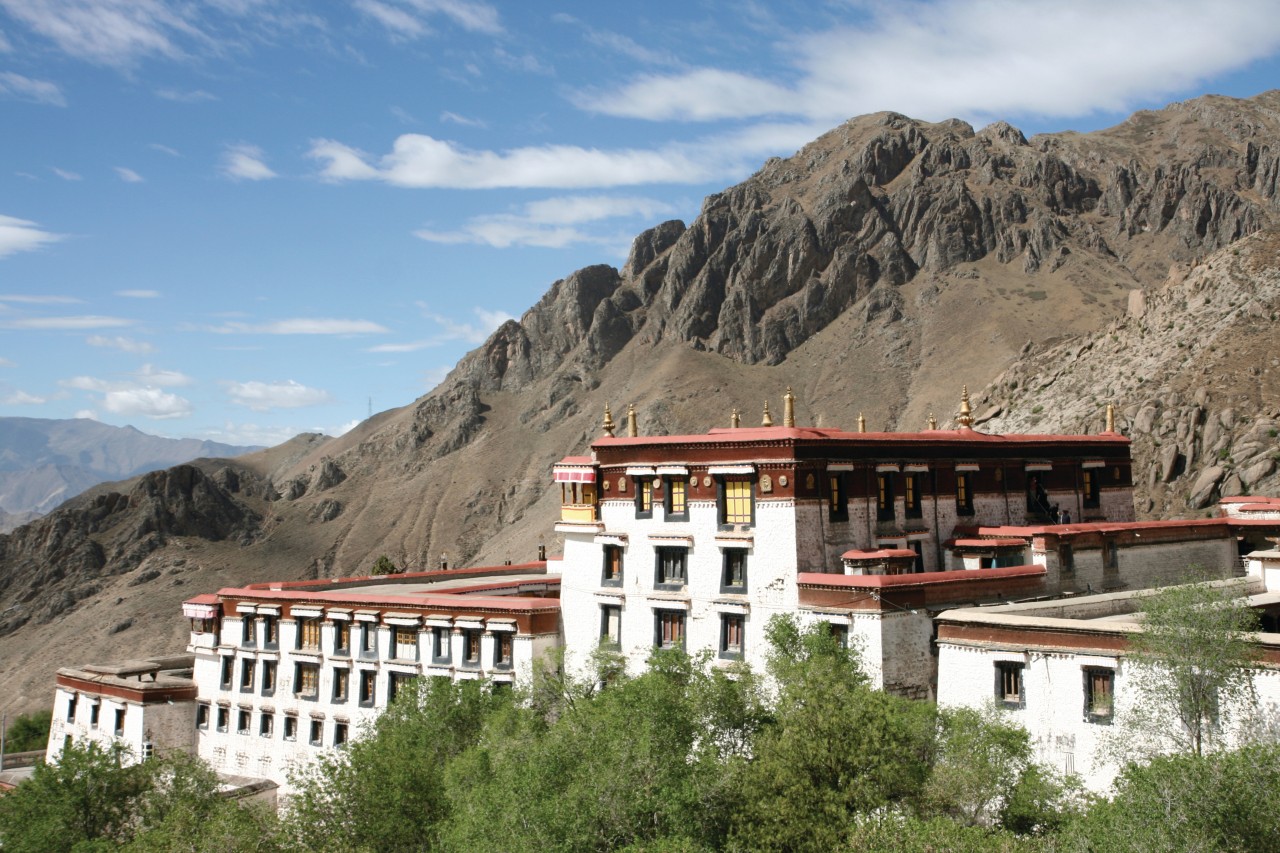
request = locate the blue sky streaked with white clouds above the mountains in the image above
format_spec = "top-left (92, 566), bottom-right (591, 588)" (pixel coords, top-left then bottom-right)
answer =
top-left (0, 0), bottom-right (1280, 443)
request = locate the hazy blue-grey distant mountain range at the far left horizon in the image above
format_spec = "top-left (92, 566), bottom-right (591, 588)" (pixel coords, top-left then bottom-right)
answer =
top-left (0, 418), bottom-right (261, 533)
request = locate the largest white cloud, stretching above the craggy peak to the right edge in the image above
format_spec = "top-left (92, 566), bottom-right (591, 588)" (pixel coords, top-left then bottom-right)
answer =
top-left (575, 0), bottom-right (1280, 123)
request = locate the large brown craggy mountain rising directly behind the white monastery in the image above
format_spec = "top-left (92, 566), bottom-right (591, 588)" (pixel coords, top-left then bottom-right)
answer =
top-left (0, 92), bottom-right (1280, 708)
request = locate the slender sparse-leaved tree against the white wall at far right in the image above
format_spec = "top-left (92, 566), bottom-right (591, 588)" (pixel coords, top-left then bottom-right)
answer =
top-left (1117, 573), bottom-right (1258, 756)
